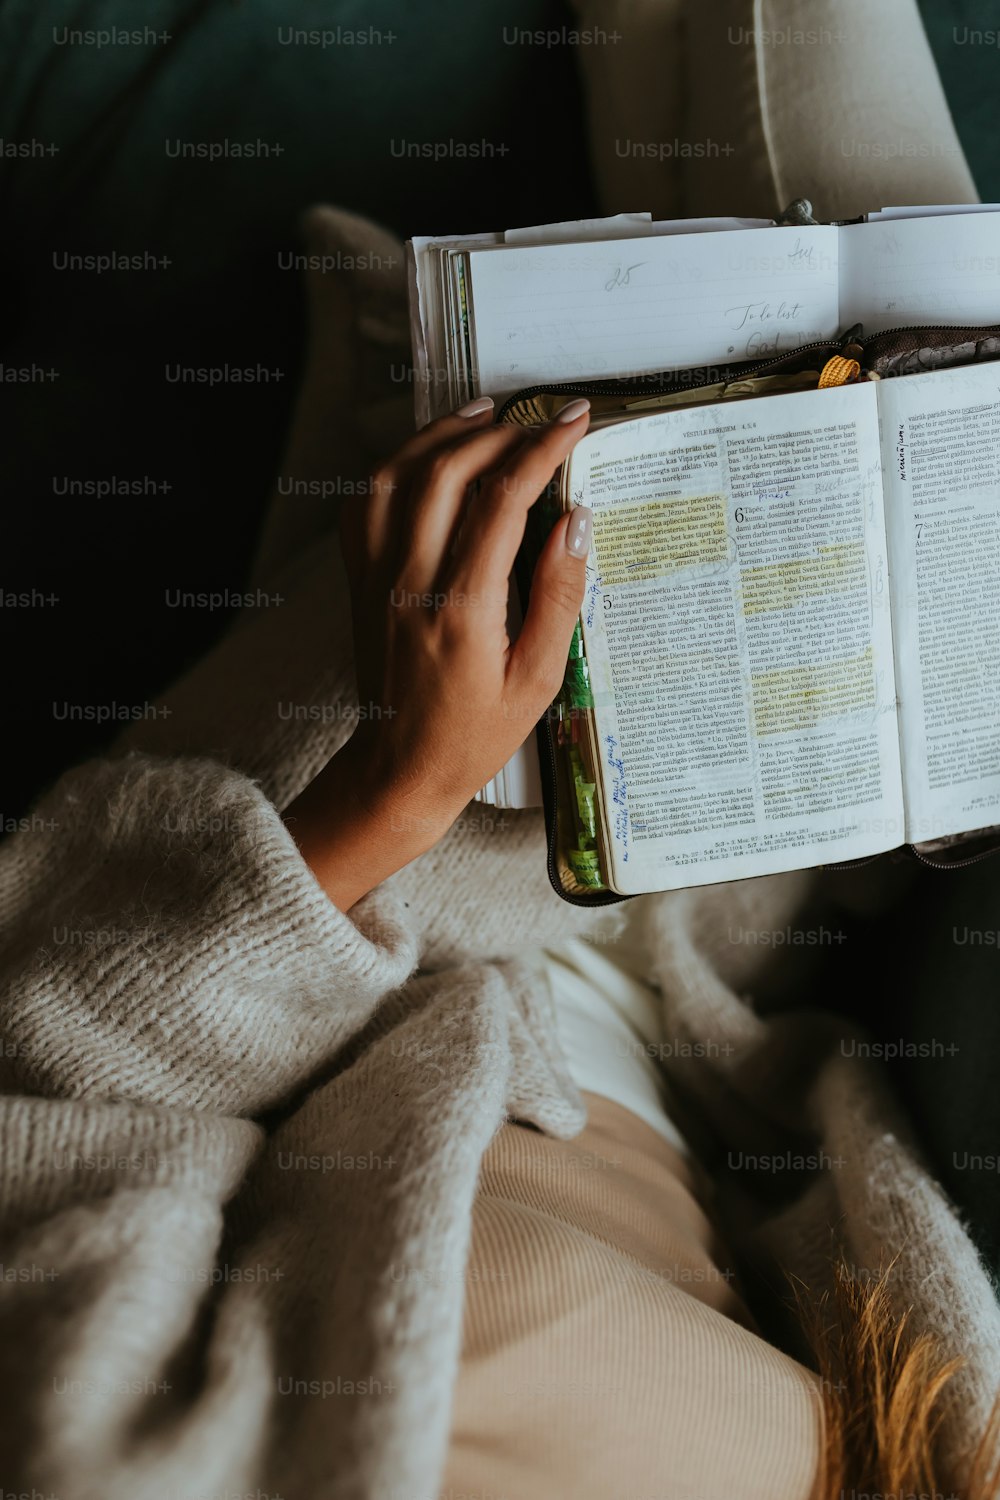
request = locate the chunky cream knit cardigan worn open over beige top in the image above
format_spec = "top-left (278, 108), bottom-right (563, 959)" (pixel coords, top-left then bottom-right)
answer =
top-left (0, 214), bottom-right (1000, 1500)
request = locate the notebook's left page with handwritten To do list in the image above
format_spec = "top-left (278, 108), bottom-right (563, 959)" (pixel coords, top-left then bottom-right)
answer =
top-left (469, 225), bottom-right (840, 401)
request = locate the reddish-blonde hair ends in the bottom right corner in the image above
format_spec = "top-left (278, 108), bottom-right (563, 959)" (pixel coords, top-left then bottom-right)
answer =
top-left (793, 1259), bottom-right (1000, 1500)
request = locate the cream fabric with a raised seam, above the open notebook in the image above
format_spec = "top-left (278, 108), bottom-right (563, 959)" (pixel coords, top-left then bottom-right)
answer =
top-left (576, 0), bottom-right (978, 219)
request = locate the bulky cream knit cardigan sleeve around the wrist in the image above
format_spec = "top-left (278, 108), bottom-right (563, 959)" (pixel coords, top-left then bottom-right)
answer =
top-left (0, 755), bottom-right (414, 1116)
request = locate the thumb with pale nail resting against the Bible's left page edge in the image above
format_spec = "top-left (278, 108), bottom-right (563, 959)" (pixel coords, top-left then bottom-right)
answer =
top-left (508, 506), bottom-right (594, 717)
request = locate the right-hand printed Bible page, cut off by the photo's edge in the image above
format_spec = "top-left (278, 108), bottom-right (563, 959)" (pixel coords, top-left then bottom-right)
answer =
top-left (879, 363), bottom-right (1000, 843)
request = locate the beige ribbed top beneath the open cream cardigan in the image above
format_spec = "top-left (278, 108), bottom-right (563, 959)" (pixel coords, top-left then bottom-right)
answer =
top-left (441, 1095), bottom-right (822, 1500)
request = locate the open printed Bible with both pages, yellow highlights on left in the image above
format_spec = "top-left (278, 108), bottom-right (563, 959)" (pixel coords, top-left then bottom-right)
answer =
top-left (564, 363), bottom-right (1000, 894)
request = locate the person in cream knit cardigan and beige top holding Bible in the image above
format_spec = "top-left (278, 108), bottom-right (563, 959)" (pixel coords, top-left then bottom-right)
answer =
top-left (0, 2), bottom-right (1000, 1500)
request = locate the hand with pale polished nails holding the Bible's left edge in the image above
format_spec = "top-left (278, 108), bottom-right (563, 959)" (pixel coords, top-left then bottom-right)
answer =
top-left (286, 401), bottom-right (591, 911)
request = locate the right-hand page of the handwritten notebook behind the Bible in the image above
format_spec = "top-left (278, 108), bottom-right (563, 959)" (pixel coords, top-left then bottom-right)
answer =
top-left (840, 213), bottom-right (1000, 335)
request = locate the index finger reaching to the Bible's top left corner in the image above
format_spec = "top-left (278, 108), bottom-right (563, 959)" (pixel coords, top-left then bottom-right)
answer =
top-left (453, 401), bottom-right (591, 594)
